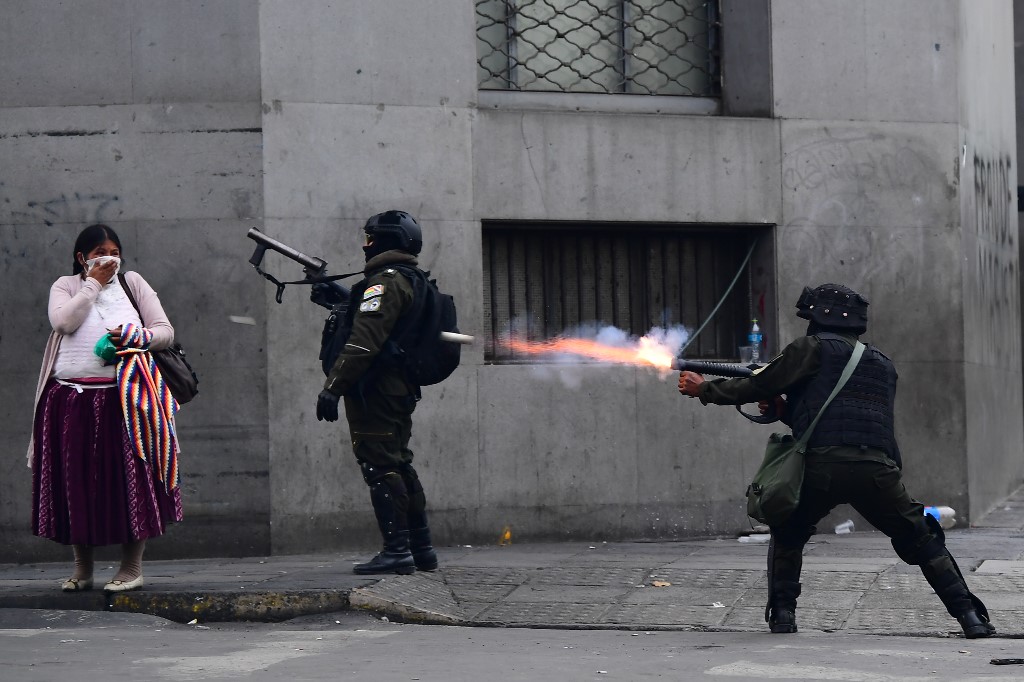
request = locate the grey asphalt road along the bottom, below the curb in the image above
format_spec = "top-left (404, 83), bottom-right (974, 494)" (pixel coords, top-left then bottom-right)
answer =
top-left (0, 609), bottom-right (1024, 682)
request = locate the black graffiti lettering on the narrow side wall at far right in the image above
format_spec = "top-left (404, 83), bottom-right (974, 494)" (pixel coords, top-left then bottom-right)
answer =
top-left (968, 154), bottom-right (1020, 360)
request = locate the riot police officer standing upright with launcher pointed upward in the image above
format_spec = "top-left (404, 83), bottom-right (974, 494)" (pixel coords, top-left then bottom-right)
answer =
top-left (313, 211), bottom-right (437, 574)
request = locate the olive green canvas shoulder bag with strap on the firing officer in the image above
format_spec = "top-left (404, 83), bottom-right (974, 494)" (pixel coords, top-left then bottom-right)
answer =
top-left (746, 341), bottom-right (864, 526)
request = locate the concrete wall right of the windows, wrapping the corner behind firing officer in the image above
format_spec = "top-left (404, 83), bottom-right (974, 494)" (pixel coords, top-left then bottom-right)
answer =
top-left (772, 0), bottom-right (1022, 517)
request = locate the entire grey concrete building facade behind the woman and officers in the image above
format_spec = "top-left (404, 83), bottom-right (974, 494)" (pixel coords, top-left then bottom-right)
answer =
top-left (0, 0), bottom-right (1024, 560)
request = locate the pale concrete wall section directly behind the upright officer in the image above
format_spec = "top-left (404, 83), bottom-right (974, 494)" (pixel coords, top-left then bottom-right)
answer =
top-left (260, 0), bottom-right (482, 552)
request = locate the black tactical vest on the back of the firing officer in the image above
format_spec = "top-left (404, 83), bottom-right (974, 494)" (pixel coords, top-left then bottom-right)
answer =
top-left (787, 333), bottom-right (901, 464)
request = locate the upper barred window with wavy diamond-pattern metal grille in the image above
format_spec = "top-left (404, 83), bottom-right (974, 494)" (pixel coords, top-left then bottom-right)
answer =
top-left (476, 0), bottom-right (721, 96)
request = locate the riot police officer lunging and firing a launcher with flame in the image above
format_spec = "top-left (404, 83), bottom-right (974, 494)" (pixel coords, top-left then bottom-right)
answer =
top-left (679, 284), bottom-right (995, 639)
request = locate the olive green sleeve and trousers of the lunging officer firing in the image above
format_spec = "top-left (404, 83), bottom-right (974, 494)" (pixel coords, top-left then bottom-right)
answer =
top-left (697, 334), bottom-right (987, 632)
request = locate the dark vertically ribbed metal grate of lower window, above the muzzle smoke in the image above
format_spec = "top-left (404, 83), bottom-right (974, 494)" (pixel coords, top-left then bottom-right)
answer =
top-left (483, 222), bottom-right (756, 364)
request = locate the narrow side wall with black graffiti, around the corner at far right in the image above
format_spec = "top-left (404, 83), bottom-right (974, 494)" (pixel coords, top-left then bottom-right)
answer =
top-left (959, 3), bottom-right (1024, 514)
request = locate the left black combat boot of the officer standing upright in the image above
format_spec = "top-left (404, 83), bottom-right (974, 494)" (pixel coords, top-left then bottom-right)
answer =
top-left (352, 472), bottom-right (416, 576)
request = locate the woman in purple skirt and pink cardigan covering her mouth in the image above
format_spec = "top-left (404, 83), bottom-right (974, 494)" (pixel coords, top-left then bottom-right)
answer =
top-left (29, 224), bottom-right (182, 592)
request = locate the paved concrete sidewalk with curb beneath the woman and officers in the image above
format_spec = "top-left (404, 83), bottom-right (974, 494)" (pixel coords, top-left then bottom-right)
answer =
top-left (6, 493), bottom-right (1024, 638)
